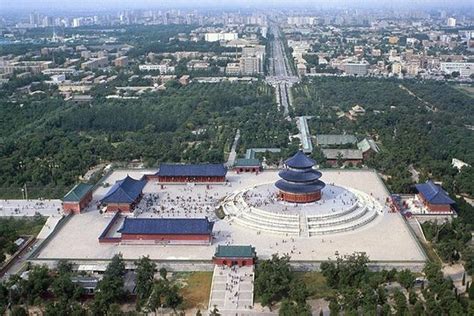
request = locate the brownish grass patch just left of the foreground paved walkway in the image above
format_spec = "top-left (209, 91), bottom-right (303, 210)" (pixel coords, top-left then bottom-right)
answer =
top-left (177, 272), bottom-right (212, 309)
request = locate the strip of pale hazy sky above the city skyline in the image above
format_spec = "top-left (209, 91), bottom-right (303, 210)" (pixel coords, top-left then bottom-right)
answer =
top-left (0, 0), bottom-right (474, 11)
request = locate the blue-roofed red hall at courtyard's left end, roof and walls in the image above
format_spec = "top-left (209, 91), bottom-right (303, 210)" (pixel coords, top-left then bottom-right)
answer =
top-left (101, 175), bottom-right (146, 212)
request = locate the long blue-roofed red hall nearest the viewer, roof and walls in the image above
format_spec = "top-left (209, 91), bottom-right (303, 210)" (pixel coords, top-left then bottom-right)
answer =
top-left (118, 217), bottom-right (214, 245)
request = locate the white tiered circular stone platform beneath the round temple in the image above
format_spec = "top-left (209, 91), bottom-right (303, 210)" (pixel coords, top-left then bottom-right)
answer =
top-left (222, 183), bottom-right (383, 237)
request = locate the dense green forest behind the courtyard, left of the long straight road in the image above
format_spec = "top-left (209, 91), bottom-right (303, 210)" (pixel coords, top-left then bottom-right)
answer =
top-left (0, 82), bottom-right (295, 197)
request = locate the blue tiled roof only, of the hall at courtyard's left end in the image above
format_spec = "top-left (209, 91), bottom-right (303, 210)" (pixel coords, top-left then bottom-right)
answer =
top-left (101, 175), bottom-right (146, 204)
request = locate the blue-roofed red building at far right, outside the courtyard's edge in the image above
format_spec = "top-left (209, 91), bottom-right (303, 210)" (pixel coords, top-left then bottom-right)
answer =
top-left (415, 180), bottom-right (455, 213)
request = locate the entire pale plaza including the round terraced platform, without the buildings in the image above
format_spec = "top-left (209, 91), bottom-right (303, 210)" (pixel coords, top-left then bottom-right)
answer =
top-left (32, 169), bottom-right (426, 271)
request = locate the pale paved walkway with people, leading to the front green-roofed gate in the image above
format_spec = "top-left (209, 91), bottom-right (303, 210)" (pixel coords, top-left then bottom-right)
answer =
top-left (209, 265), bottom-right (255, 315)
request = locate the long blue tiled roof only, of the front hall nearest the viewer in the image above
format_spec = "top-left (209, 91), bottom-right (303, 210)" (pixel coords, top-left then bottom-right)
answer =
top-left (119, 217), bottom-right (214, 235)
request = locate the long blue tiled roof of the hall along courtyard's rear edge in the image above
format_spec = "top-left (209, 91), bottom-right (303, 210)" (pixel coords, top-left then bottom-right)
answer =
top-left (156, 164), bottom-right (227, 177)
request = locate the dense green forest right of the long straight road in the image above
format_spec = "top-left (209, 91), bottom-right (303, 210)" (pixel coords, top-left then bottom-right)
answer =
top-left (293, 77), bottom-right (474, 196)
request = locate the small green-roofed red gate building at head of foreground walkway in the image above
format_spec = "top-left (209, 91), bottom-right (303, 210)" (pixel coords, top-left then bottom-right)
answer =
top-left (212, 245), bottom-right (257, 267)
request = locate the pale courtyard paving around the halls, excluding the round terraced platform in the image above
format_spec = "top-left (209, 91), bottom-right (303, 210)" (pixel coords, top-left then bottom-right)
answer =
top-left (33, 170), bottom-right (426, 262)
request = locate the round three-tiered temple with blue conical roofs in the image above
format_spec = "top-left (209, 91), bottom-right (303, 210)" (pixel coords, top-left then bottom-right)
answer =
top-left (275, 151), bottom-right (326, 203)
